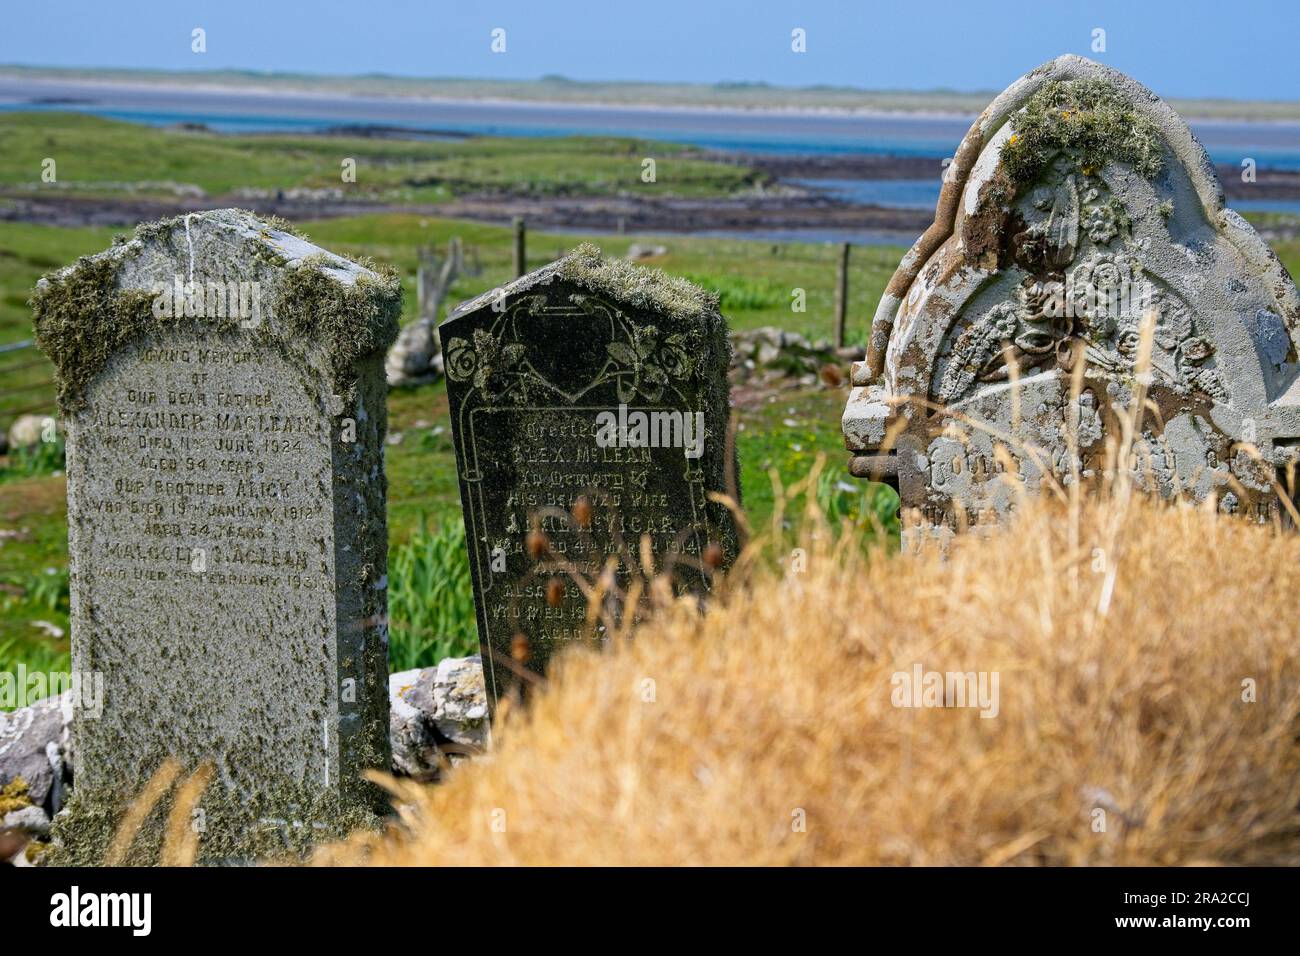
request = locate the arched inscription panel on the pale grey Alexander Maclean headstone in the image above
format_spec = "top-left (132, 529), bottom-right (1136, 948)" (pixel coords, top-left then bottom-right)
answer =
top-left (69, 336), bottom-right (337, 786)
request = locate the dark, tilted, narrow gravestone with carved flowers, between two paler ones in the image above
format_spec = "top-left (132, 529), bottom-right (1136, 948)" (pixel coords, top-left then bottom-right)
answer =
top-left (439, 246), bottom-right (738, 705)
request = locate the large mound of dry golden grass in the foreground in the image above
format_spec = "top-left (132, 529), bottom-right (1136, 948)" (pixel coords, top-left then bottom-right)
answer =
top-left (319, 478), bottom-right (1300, 865)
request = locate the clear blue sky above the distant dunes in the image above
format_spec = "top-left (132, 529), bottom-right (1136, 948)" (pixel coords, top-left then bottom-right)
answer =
top-left (0, 0), bottom-right (1300, 99)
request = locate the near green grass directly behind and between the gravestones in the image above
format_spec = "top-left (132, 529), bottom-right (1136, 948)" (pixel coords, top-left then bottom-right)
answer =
top-left (0, 141), bottom-right (902, 686)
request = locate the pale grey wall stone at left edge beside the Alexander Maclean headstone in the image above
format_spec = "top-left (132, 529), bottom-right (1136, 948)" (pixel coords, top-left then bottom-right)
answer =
top-left (0, 691), bottom-right (73, 813)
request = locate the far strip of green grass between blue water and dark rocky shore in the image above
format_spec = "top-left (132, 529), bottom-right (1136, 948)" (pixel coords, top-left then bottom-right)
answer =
top-left (0, 112), bottom-right (764, 203)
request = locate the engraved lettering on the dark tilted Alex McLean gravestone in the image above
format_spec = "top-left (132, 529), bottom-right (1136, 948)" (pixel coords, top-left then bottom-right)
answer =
top-left (468, 406), bottom-right (707, 657)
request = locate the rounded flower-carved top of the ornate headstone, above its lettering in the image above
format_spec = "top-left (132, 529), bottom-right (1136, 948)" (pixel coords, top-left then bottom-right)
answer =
top-left (857, 56), bottom-right (1300, 411)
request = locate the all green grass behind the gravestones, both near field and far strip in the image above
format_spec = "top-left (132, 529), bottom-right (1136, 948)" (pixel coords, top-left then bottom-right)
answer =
top-left (0, 113), bottom-right (1300, 697)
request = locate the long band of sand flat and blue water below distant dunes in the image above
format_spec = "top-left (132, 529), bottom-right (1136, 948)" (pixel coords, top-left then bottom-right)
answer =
top-left (0, 68), bottom-right (1300, 169)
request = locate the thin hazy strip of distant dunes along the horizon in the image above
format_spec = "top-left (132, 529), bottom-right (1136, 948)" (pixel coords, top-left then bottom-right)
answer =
top-left (0, 65), bottom-right (1300, 120)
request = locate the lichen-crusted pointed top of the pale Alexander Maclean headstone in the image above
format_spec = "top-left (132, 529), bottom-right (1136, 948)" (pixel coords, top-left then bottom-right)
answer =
top-left (31, 209), bottom-right (402, 411)
